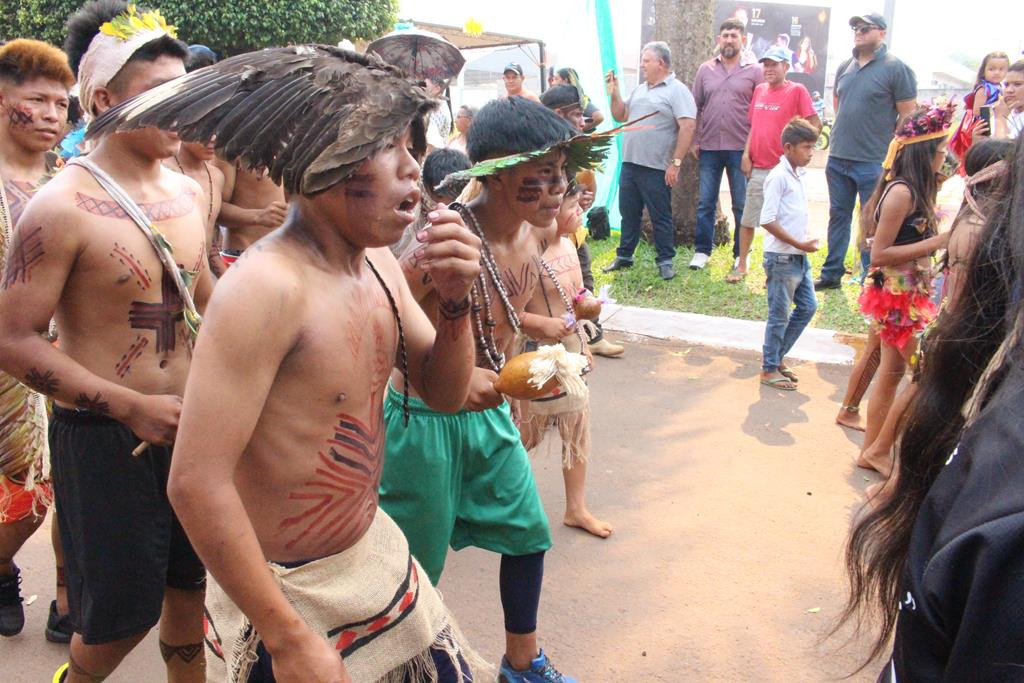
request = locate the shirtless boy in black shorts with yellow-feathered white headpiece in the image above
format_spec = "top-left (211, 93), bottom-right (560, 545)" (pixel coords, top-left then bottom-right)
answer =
top-left (0, 2), bottom-right (211, 683)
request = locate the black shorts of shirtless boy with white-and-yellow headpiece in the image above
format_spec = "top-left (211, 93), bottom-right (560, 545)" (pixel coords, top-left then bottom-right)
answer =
top-left (50, 405), bottom-right (206, 645)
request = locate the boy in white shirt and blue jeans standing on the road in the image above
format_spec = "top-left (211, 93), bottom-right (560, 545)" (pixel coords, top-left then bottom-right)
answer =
top-left (761, 117), bottom-right (818, 391)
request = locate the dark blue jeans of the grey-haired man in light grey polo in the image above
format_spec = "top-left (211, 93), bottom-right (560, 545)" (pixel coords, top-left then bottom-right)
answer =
top-left (615, 162), bottom-right (676, 265)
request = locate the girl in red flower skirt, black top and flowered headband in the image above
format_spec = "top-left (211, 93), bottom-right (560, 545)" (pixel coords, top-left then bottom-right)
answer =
top-left (857, 108), bottom-right (952, 476)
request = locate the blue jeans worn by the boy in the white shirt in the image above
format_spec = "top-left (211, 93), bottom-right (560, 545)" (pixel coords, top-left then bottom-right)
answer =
top-left (761, 252), bottom-right (818, 373)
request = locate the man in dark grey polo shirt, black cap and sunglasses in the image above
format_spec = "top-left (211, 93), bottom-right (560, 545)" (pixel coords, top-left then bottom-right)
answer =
top-left (814, 13), bottom-right (918, 290)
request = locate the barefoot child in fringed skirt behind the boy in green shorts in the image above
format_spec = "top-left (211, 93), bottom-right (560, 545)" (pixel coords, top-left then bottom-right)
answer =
top-left (519, 183), bottom-right (611, 539)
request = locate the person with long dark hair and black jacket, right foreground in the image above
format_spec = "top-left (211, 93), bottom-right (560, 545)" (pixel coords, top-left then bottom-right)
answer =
top-left (837, 133), bottom-right (1024, 682)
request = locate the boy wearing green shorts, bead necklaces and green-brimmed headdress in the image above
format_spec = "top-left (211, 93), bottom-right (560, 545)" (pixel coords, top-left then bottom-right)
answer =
top-left (380, 97), bottom-right (593, 683)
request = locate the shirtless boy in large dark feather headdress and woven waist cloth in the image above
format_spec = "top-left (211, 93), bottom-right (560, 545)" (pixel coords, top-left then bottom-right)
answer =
top-left (87, 45), bottom-right (479, 683)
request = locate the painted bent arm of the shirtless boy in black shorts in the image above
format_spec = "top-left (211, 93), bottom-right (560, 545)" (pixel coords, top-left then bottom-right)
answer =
top-left (0, 197), bottom-right (181, 444)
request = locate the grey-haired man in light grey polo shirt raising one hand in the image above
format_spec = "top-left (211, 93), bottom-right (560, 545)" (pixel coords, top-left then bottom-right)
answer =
top-left (604, 42), bottom-right (697, 280)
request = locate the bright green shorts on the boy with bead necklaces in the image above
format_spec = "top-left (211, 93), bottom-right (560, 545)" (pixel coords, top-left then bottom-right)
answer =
top-left (380, 386), bottom-right (551, 584)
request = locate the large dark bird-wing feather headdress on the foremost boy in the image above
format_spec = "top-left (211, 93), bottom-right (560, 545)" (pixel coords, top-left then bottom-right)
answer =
top-left (87, 45), bottom-right (436, 196)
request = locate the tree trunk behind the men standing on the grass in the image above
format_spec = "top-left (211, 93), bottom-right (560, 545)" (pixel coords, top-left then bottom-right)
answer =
top-left (642, 0), bottom-right (731, 246)
